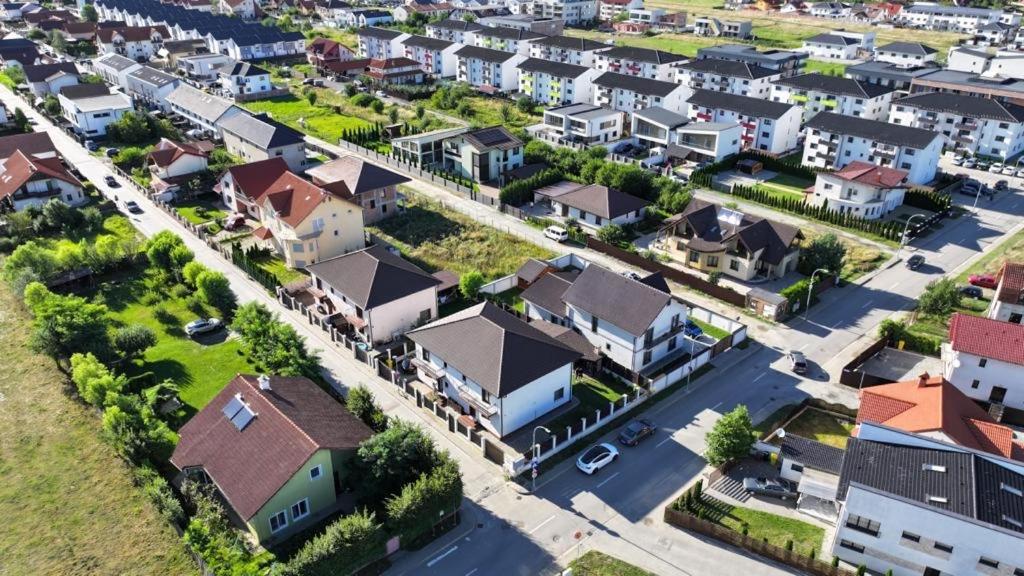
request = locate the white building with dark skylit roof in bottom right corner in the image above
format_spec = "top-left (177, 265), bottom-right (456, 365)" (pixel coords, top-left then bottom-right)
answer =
top-left (830, 432), bottom-right (1024, 576)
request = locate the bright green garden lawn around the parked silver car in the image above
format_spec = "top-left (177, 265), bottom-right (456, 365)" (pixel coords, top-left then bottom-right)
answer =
top-left (86, 272), bottom-right (257, 410)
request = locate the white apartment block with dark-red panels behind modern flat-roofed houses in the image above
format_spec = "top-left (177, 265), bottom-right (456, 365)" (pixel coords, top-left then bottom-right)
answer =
top-left (687, 90), bottom-right (802, 154)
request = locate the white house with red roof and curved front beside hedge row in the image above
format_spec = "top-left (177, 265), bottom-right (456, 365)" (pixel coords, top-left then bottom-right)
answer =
top-left (807, 160), bottom-right (909, 220)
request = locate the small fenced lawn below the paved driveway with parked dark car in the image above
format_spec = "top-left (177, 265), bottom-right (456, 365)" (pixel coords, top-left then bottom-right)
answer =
top-left (695, 494), bottom-right (825, 556)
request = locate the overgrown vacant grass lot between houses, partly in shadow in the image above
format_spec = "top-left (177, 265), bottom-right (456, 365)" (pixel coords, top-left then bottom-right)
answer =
top-left (367, 194), bottom-right (554, 282)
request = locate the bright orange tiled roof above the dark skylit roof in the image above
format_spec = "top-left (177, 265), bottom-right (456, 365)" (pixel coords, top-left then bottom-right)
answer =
top-left (857, 373), bottom-right (1022, 458)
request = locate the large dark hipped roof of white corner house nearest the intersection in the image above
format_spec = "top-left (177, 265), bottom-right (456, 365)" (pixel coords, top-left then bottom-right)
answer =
top-left (407, 302), bottom-right (582, 398)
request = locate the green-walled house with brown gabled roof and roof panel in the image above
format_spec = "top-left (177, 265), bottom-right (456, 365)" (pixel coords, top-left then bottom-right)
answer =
top-left (171, 374), bottom-right (373, 544)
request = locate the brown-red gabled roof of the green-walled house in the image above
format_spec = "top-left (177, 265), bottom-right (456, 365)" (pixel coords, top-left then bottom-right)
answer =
top-left (171, 374), bottom-right (373, 520)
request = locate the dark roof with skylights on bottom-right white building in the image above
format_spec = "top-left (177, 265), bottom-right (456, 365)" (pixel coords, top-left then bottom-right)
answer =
top-left (838, 438), bottom-right (1024, 533)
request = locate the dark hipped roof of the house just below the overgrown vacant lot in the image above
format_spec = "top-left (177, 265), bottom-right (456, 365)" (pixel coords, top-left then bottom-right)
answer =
top-left (306, 244), bottom-right (440, 308)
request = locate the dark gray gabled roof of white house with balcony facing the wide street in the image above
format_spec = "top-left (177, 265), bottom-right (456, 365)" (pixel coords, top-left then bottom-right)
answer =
top-left (562, 264), bottom-right (672, 336)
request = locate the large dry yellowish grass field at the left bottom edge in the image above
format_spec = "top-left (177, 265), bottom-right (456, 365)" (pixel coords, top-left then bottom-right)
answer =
top-left (0, 283), bottom-right (198, 576)
